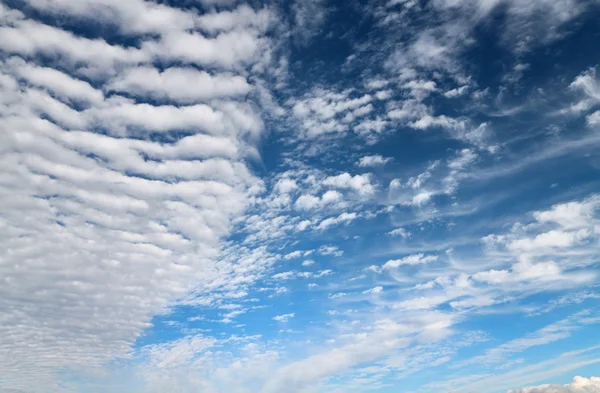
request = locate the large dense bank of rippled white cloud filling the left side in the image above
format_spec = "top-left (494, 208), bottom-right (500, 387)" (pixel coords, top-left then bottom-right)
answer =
top-left (0, 0), bottom-right (282, 391)
